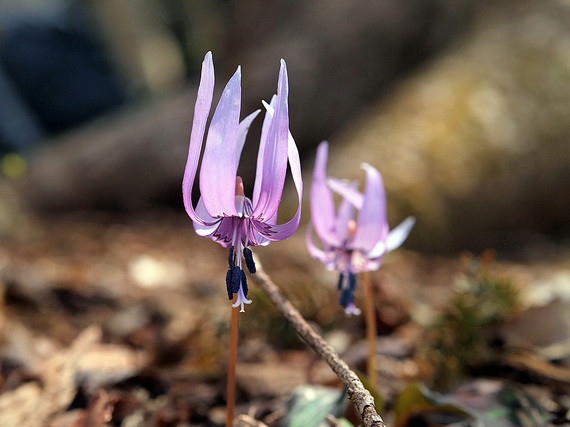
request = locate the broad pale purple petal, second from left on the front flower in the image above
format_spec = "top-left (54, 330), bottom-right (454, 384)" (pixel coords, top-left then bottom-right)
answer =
top-left (200, 67), bottom-right (241, 221)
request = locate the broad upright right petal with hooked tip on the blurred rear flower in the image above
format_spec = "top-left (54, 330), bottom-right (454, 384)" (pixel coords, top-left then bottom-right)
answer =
top-left (352, 163), bottom-right (388, 252)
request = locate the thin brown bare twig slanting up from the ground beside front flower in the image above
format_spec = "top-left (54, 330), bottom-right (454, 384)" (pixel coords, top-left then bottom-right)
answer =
top-left (253, 255), bottom-right (386, 427)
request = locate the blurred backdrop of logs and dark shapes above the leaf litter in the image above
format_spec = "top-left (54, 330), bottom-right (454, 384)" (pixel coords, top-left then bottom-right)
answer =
top-left (0, 0), bottom-right (570, 252)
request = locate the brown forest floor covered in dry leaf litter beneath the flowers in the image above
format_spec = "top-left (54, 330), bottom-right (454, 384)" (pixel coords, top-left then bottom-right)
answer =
top-left (0, 212), bottom-right (570, 427)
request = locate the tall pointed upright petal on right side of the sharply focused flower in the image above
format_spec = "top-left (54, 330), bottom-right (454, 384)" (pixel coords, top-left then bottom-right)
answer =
top-left (252, 60), bottom-right (289, 221)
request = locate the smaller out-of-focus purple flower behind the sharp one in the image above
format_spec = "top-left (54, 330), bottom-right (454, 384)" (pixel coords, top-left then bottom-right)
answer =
top-left (306, 141), bottom-right (415, 314)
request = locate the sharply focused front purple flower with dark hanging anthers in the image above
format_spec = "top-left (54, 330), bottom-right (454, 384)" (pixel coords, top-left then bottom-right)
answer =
top-left (182, 52), bottom-right (303, 311)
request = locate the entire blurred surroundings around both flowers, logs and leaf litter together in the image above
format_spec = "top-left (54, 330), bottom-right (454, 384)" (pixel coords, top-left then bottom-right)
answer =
top-left (0, 0), bottom-right (570, 427)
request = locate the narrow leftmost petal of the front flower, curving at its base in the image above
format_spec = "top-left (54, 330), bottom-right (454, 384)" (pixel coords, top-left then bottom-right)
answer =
top-left (182, 52), bottom-right (214, 223)
